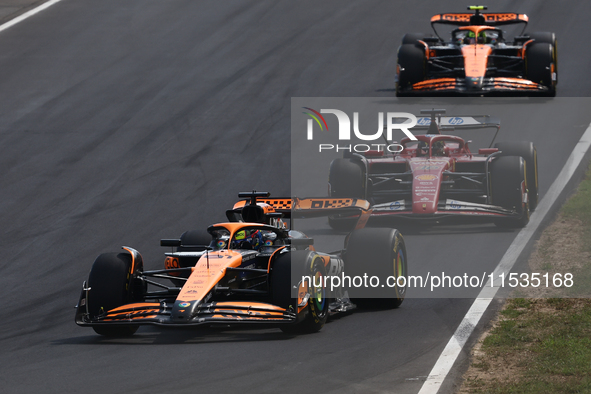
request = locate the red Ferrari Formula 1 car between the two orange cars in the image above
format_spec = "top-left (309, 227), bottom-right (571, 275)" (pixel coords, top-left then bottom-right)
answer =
top-left (328, 109), bottom-right (538, 229)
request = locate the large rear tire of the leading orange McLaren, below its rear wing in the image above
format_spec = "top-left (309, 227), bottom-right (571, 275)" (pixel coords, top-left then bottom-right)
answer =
top-left (344, 228), bottom-right (408, 309)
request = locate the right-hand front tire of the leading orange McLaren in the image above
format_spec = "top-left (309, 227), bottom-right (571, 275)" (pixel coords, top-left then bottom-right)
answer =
top-left (271, 250), bottom-right (329, 334)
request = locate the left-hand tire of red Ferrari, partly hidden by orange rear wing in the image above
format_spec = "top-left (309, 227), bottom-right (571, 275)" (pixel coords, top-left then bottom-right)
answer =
top-left (328, 158), bottom-right (366, 231)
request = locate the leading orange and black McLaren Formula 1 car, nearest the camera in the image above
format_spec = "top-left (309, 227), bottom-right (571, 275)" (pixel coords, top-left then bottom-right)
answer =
top-left (76, 192), bottom-right (407, 336)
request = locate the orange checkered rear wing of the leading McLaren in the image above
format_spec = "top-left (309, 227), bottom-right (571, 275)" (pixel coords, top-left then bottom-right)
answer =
top-left (226, 192), bottom-right (372, 229)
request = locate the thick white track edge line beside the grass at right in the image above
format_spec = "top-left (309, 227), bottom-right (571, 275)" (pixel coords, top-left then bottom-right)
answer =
top-left (419, 124), bottom-right (591, 394)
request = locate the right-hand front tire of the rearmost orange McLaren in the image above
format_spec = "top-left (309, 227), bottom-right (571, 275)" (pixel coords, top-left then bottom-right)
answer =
top-left (525, 42), bottom-right (558, 97)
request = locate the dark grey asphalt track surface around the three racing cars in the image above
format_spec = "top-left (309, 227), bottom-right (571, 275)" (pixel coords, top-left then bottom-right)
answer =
top-left (0, 0), bottom-right (591, 393)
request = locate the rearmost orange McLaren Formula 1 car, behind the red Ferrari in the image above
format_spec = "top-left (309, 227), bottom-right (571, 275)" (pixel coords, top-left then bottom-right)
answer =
top-left (396, 6), bottom-right (558, 96)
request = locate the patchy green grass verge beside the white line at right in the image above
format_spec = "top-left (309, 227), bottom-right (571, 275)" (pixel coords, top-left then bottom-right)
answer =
top-left (464, 162), bottom-right (591, 394)
